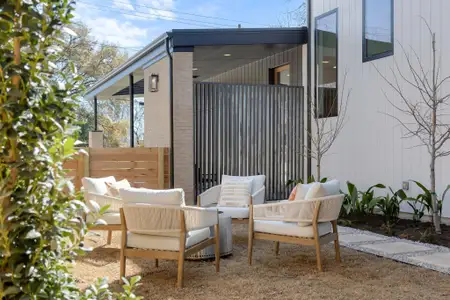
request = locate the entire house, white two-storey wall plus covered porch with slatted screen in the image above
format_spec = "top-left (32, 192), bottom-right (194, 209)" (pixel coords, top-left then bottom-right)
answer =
top-left (86, 0), bottom-right (450, 217)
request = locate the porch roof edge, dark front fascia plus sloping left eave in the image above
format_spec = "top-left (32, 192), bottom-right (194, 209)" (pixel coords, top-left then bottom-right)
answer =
top-left (85, 27), bottom-right (308, 99)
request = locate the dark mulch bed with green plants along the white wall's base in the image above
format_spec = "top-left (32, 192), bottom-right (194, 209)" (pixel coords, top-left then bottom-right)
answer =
top-left (341, 215), bottom-right (450, 247)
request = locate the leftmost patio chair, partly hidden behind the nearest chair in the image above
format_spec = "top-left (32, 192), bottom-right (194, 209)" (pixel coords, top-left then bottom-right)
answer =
top-left (82, 176), bottom-right (123, 245)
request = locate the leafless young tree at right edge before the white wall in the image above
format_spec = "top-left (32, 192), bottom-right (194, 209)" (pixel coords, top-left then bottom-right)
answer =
top-left (377, 22), bottom-right (450, 234)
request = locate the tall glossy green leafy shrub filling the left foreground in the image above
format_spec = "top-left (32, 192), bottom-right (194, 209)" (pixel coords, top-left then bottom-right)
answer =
top-left (0, 0), bottom-right (141, 299)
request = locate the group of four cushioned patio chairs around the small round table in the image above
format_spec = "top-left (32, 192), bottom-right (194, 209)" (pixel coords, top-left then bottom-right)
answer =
top-left (82, 175), bottom-right (352, 287)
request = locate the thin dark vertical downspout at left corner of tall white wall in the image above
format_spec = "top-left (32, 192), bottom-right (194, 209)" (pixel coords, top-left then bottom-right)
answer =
top-left (306, 0), bottom-right (312, 180)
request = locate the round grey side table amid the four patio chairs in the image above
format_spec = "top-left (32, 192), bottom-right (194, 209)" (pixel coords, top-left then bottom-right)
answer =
top-left (187, 214), bottom-right (233, 260)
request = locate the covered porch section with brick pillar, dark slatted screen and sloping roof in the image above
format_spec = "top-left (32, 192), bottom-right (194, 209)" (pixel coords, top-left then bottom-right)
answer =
top-left (85, 28), bottom-right (308, 204)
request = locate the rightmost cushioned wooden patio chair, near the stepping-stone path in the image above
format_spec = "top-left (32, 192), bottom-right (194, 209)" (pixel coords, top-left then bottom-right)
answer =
top-left (248, 183), bottom-right (344, 271)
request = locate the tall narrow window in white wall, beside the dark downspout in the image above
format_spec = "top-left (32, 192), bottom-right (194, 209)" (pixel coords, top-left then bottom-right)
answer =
top-left (315, 9), bottom-right (338, 118)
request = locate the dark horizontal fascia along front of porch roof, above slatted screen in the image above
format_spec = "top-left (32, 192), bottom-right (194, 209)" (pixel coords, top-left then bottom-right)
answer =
top-left (170, 27), bottom-right (308, 48)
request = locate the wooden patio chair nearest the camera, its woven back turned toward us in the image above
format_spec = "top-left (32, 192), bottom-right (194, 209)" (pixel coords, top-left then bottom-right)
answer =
top-left (120, 199), bottom-right (220, 287)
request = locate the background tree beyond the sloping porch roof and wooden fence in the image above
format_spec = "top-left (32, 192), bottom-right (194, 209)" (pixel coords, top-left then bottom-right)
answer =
top-left (56, 22), bottom-right (143, 147)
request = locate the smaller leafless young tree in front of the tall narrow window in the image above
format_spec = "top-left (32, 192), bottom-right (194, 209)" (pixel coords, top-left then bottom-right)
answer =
top-left (306, 72), bottom-right (351, 180)
